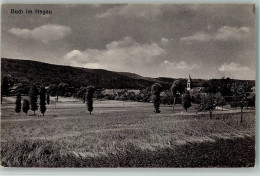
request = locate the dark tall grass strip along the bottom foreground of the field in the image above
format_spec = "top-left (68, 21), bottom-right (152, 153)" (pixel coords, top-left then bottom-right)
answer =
top-left (1, 137), bottom-right (255, 167)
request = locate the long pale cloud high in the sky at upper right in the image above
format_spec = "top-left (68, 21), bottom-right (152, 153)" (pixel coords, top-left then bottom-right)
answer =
top-left (180, 26), bottom-right (250, 43)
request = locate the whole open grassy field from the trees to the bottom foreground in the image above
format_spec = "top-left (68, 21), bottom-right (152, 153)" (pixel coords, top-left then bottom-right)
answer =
top-left (1, 98), bottom-right (255, 167)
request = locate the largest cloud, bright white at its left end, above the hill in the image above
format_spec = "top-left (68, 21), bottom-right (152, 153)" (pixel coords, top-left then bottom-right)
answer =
top-left (64, 37), bottom-right (166, 71)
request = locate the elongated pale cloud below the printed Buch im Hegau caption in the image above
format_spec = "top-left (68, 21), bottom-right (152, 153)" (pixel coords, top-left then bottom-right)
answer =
top-left (9, 24), bottom-right (72, 43)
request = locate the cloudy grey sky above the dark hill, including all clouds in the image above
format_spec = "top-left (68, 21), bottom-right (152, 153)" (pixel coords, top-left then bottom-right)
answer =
top-left (1, 4), bottom-right (256, 80)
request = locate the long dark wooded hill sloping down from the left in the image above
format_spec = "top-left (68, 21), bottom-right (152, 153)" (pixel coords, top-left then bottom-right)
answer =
top-left (1, 58), bottom-right (181, 89)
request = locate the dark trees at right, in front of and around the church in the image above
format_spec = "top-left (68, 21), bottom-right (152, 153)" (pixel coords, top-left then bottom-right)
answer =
top-left (151, 78), bottom-right (251, 123)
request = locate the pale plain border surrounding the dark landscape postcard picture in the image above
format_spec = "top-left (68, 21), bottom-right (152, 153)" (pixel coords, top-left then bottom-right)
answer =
top-left (0, 0), bottom-right (260, 176)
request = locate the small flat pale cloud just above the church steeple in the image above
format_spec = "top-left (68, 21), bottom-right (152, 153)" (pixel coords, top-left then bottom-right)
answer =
top-left (162, 60), bottom-right (200, 70)
